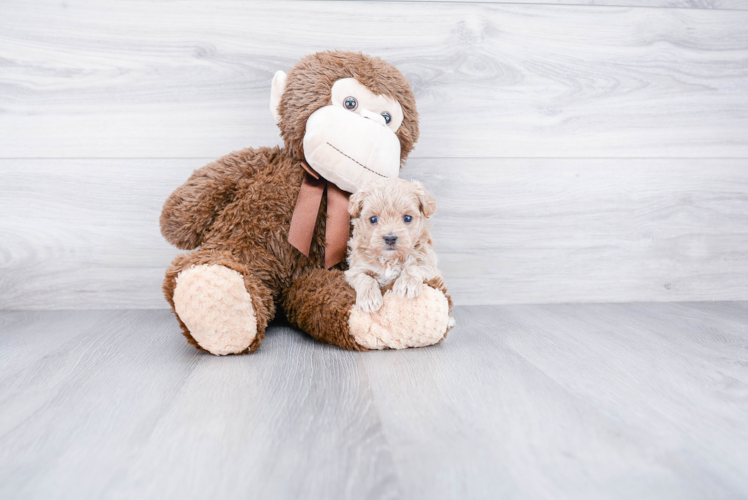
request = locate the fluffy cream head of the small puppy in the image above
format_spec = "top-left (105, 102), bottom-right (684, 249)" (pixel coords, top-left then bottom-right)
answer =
top-left (348, 179), bottom-right (436, 259)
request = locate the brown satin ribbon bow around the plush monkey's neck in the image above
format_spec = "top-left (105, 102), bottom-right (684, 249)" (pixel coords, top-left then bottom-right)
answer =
top-left (288, 162), bottom-right (351, 269)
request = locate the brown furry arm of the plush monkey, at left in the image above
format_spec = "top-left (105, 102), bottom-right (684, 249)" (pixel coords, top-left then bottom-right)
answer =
top-left (160, 153), bottom-right (256, 250)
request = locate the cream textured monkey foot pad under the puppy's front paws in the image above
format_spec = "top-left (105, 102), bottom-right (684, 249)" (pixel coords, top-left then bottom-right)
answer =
top-left (348, 285), bottom-right (453, 349)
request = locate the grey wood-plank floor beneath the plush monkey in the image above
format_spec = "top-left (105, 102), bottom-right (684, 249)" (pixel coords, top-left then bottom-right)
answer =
top-left (0, 302), bottom-right (748, 499)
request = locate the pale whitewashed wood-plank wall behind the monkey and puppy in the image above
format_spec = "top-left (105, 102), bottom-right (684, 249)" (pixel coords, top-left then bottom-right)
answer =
top-left (0, 0), bottom-right (748, 309)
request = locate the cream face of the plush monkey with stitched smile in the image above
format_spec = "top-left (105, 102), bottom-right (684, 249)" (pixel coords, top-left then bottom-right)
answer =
top-left (304, 78), bottom-right (403, 193)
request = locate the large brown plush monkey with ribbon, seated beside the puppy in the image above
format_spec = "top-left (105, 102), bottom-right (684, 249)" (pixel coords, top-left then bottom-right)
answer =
top-left (161, 51), bottom-right (452, 355)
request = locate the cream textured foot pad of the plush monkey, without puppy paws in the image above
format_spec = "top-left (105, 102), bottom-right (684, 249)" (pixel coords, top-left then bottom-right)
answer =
top-left (174, 264), bottom-right (257, 356)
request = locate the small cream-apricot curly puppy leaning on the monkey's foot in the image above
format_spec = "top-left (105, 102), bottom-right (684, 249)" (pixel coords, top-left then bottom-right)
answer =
top-left (345, 179), bottom-right (439, 312)
